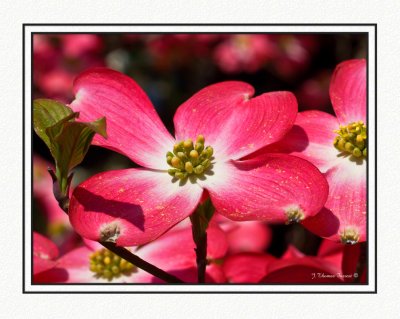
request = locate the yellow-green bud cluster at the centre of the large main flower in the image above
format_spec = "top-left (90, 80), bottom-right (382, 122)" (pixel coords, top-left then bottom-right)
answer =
top-left (167, 135), bottom-right (214, 180)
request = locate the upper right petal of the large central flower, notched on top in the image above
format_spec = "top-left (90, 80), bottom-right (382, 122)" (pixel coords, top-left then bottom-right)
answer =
top-left (174, 82), bottom-right (297, 159)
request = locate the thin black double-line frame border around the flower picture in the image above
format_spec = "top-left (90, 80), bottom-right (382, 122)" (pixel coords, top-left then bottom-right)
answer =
top-left (22, 23), bottom-right (378, 294)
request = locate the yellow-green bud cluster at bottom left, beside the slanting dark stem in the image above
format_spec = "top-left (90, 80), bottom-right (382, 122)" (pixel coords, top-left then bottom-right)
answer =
top-left (89, 248), bottom-right (136, 281)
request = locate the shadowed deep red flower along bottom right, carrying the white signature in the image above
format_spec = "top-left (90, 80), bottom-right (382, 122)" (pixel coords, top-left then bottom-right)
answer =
top-left (222, 240), bottom-right (365, 284)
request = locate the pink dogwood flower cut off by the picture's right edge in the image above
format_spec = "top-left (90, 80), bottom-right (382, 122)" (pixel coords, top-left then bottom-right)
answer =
top-left (260, 60), bottom-right (367, 244)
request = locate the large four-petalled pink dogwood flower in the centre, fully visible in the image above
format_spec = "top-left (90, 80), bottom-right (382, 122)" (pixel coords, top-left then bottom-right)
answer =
top-left (69, 68), bottom-right (328, 246)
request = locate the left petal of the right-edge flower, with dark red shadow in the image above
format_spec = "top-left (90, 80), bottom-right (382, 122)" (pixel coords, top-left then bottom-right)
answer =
top-left (250, 111), bottom-right (342, 172)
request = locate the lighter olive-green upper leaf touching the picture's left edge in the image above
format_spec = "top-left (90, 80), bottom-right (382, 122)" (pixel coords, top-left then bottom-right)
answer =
top-left (33, 99), bottom-right (79, 148)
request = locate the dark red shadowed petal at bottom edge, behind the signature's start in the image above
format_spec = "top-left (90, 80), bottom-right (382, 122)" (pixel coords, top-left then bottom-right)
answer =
top-left (261, 257), bottom-right (343, 284)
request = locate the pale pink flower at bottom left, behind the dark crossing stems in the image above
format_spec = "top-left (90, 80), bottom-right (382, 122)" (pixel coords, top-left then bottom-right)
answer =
top-left (35, 224), bottom-right (227, 283)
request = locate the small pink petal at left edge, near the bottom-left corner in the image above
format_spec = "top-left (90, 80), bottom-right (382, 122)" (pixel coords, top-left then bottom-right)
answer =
top-left (33, 232), bottom-right (59, 275)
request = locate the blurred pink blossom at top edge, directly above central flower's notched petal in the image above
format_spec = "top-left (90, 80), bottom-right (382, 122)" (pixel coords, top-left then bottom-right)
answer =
top-left (214, 34), bottom-right (277, 73)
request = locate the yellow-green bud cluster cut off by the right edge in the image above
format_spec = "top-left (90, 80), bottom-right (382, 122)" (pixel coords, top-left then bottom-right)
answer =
top-left (333, 121), bottom-right (367, 158)
